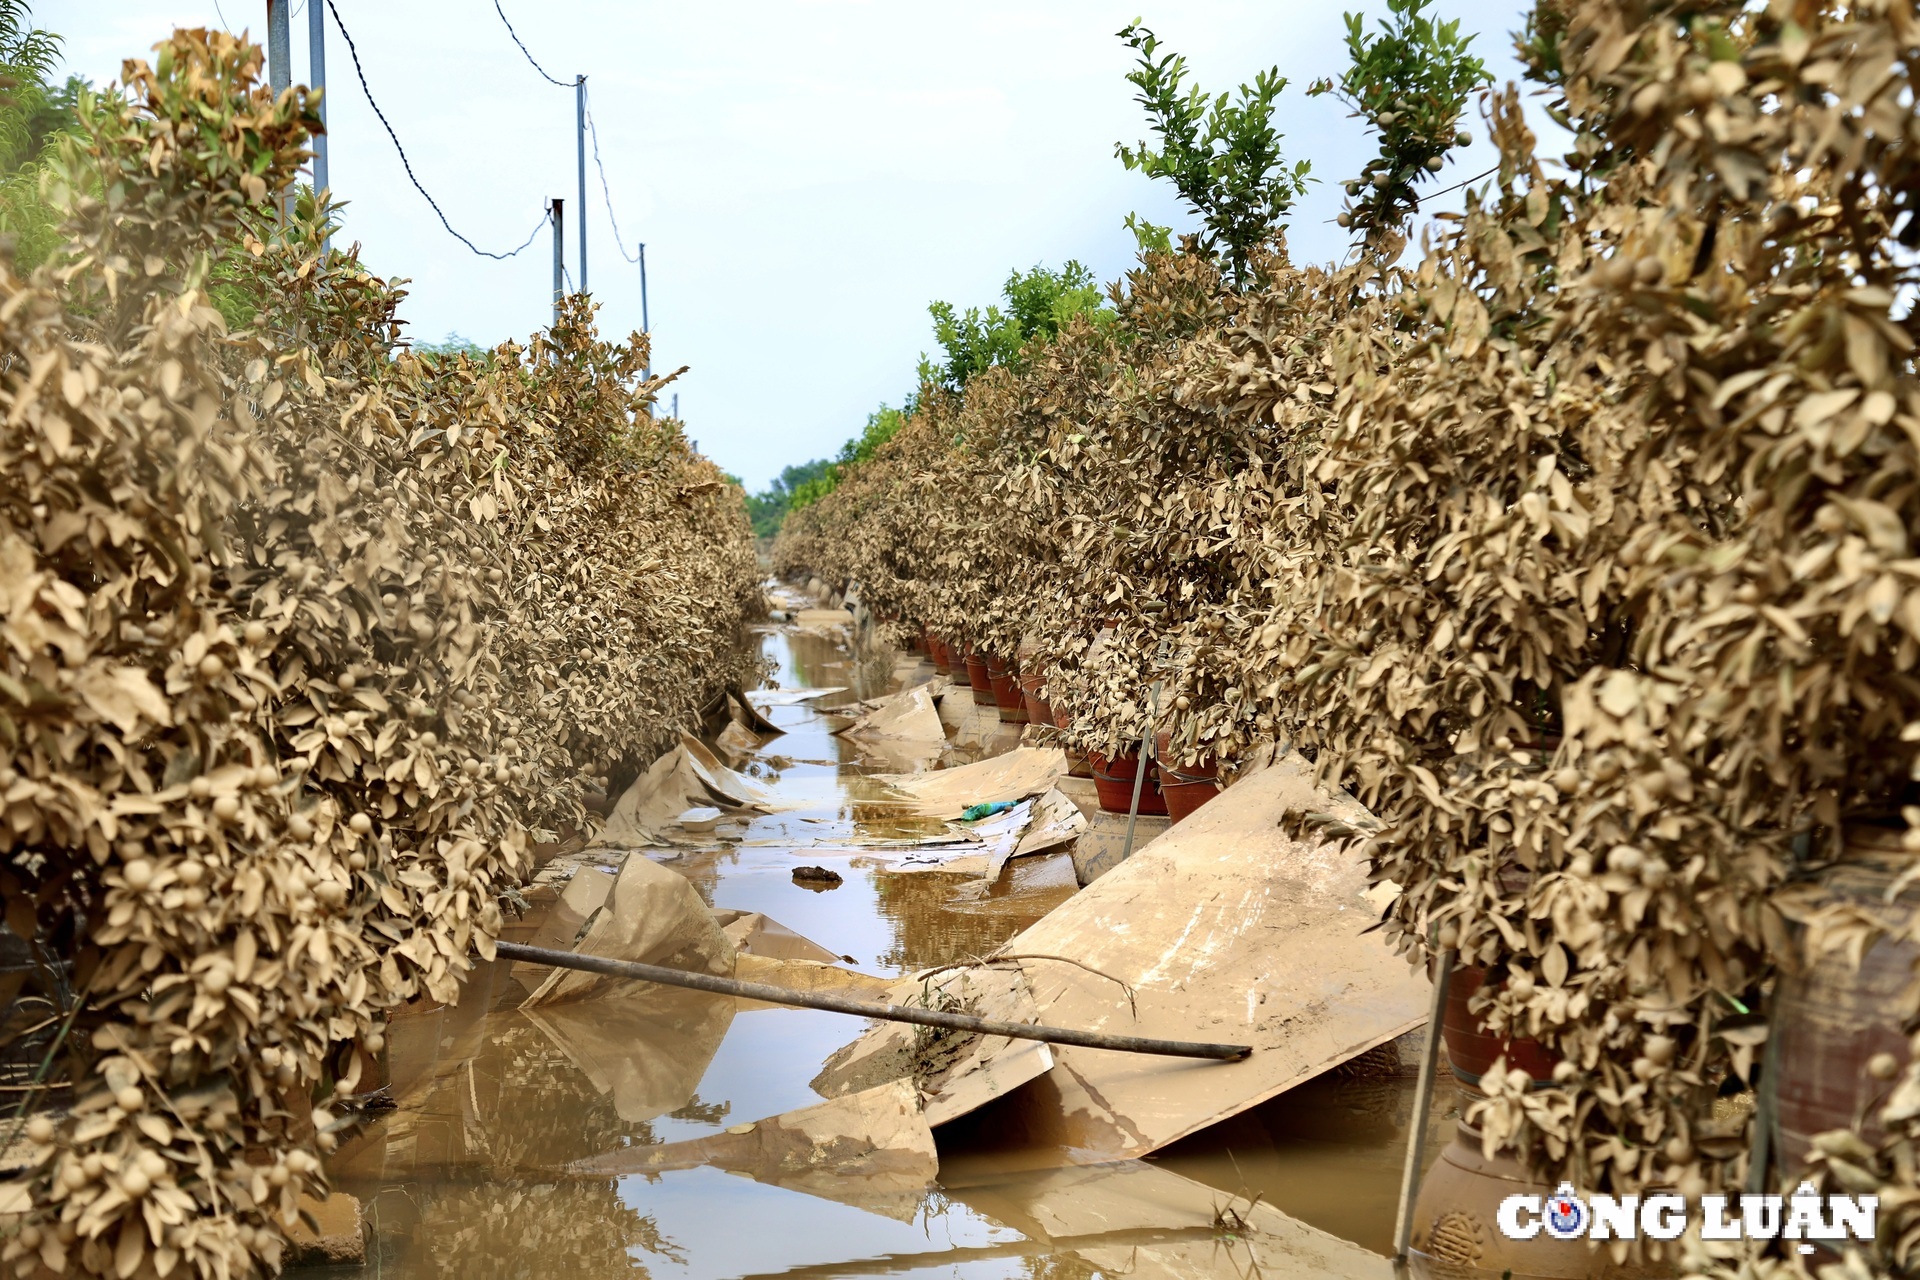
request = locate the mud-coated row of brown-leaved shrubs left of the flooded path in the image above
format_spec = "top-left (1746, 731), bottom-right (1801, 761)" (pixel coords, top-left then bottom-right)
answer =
top-left (0, 31), bottom-right (760, 1278)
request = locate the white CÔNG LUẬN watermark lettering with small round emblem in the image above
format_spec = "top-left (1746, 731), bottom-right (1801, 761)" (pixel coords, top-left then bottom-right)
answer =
top-left (1496, 1182), bottom-right (1880, 1253)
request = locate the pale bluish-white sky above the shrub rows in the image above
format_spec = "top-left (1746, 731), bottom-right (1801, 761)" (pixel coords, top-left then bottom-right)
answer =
top-left (52, 0), bottom-right (1528, 489)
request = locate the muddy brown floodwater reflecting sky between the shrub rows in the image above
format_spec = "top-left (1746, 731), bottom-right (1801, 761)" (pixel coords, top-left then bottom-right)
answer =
top-left (332, 614), bottom-right (1453, 1280)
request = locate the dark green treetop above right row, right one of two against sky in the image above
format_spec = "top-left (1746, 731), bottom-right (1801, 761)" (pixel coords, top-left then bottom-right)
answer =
top-left (1308, 0), bottom-right (1490, 253)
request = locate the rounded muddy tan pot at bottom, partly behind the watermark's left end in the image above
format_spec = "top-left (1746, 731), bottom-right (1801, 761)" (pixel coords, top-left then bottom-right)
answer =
top-left (1407, 1128), bottom-right (1617, 1280)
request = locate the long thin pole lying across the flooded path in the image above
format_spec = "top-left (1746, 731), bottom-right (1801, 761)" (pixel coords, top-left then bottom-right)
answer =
top-left (493, 942), bottom-right (1254, 1061)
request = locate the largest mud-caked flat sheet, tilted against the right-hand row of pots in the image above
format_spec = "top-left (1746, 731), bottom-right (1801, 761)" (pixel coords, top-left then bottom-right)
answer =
top-left (998, 758), bottom-right (1430, 1163)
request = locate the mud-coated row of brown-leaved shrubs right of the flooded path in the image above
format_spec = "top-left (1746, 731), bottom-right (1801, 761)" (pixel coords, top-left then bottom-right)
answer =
top-left (774, 0), bottom-right (1920, 1274)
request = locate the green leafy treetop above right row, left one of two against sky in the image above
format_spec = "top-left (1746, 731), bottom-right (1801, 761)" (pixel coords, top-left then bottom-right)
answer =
top-left (1114, 19), bottom-right (1308, 288)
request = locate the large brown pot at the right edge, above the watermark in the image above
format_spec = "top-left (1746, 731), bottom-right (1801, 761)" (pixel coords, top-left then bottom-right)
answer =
top-left (1774, 827), bottom-right (1920, 1180)
